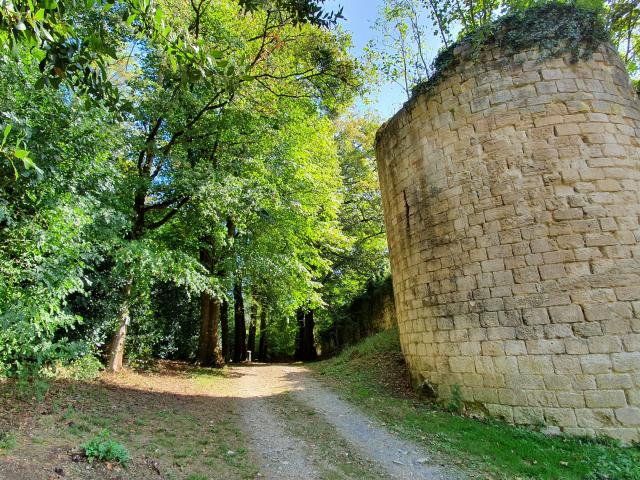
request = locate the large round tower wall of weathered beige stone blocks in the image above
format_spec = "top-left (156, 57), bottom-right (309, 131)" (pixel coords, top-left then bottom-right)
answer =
top-left (377, 45), bottom-right (640, 440)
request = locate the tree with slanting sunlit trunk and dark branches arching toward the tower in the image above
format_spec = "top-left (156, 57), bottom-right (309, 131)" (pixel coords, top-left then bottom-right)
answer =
top-left (101, 2), bottom-right (360, 371)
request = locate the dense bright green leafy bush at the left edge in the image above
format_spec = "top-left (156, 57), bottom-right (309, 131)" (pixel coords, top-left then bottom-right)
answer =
top-left (0, 50), bottom-right (125, 376)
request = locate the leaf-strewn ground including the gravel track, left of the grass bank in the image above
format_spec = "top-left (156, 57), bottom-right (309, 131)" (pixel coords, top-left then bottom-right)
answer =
top-left (0, 362), bottom-right (460, 480)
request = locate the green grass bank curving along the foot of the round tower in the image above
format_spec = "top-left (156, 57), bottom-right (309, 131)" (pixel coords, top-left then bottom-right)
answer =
top-left (312, 330), bottom-right (640, 480)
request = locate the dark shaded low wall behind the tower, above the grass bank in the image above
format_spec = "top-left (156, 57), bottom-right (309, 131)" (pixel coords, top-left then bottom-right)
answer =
top-left (320, 278), bottom-right (397, 356)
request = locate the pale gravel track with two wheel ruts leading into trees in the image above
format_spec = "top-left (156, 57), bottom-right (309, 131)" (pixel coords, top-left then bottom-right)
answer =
top-left (232, 364), bottom-right (464, 480)
